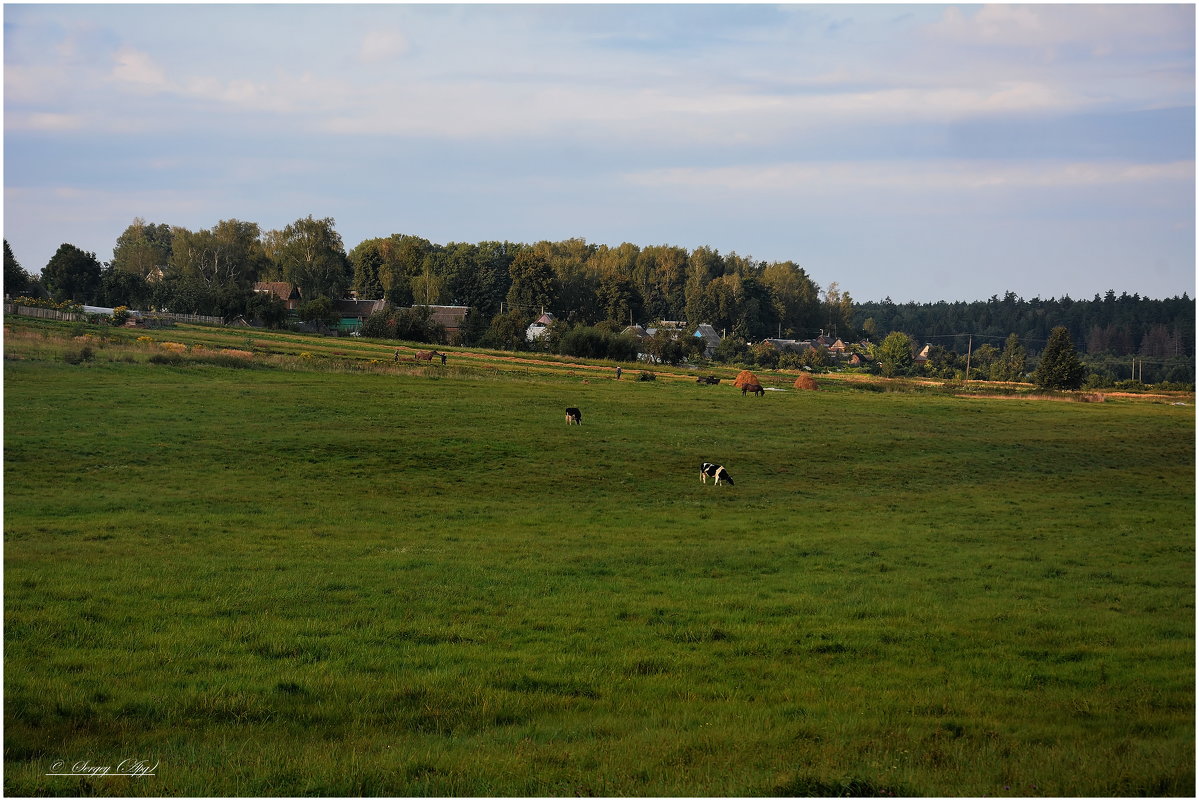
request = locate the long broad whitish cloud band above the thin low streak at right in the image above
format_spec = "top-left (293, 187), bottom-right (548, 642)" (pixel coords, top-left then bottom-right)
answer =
top-left (318, 72), bottom-right (1098, 144)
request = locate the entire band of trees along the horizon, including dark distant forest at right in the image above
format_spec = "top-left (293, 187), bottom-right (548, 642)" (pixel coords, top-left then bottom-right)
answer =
top-left (4, 216), bottom-right (1194, 383)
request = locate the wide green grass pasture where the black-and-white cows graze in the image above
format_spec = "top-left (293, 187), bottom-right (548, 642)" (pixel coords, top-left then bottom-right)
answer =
top-left (4, 320), bottom-right (1195, 797)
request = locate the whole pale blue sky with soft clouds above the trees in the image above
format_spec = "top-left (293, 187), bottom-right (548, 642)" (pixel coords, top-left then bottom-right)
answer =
top-left (4, 5), bottom-right (1195, 302)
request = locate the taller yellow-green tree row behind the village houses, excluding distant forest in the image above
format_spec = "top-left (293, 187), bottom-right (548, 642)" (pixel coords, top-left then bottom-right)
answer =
top-left (5, 216), bottom-right (852, 339)
